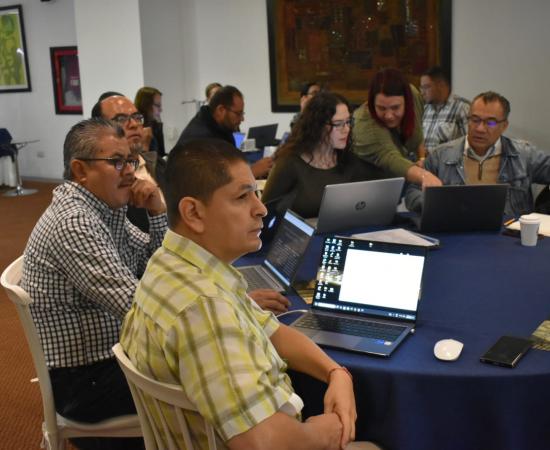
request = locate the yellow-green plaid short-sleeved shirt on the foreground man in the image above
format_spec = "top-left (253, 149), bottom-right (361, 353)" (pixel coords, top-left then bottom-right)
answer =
top-left (120, 230), bottom-right (293, 448)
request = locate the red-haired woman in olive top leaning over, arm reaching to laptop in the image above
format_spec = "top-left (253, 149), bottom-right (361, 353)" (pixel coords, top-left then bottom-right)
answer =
top-left (353, 69), bottom-right (441, 186)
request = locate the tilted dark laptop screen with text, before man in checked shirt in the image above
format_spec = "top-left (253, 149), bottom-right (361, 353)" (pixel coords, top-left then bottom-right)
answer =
top-left (264, 211), bottom-right (315, 285)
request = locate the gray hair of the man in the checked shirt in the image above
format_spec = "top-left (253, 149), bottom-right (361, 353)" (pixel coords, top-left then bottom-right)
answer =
top-left (63, 118), bottom-right (124, 180)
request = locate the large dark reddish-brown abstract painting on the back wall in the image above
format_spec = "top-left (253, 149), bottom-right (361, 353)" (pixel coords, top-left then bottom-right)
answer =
top-left (267, 0), bottom-right (452, 112)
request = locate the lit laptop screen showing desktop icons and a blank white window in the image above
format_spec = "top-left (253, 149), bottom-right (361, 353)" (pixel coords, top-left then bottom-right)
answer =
top-left (313, 236), bottom-right (427, 321)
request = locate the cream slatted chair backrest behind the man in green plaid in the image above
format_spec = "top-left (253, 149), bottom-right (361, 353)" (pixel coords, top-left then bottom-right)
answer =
top-left (113, 344), bottom-right (217, 450)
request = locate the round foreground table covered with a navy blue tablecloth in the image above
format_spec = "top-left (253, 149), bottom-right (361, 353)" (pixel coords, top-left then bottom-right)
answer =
top-left (237, 220), bottom-right (550, 450)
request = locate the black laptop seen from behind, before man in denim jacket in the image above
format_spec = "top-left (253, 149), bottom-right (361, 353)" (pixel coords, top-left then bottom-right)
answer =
top-left (415, 184), bottom-right (508, 232)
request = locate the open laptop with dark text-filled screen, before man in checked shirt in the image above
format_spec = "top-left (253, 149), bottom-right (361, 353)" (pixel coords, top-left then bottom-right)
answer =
top-left (237, 211), bottom-right (314, 292)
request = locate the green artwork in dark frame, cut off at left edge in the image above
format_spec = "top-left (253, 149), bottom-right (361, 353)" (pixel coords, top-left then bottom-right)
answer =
top-left (0, 5), bottom-right (31, 93)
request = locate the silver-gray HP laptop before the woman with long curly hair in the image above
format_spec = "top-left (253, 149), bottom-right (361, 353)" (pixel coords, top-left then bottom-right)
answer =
top-left (309, 178), bottom-right (405, 233)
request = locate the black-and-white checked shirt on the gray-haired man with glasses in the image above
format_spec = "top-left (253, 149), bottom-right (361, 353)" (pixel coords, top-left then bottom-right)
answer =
top-left (21, 181), bottom-right (167, 368)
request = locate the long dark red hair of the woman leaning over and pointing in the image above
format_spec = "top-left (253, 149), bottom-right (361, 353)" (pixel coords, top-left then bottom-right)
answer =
top-left (368, 68), bottom-right (416, 141)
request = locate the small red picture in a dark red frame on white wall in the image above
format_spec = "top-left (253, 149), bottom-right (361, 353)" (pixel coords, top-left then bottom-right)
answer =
top-left (50, 47), bottom-right (82, 114)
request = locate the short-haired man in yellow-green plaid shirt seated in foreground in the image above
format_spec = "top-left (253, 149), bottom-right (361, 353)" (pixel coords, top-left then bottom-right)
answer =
top-left (120, 140), bottom-right (366, 449)
